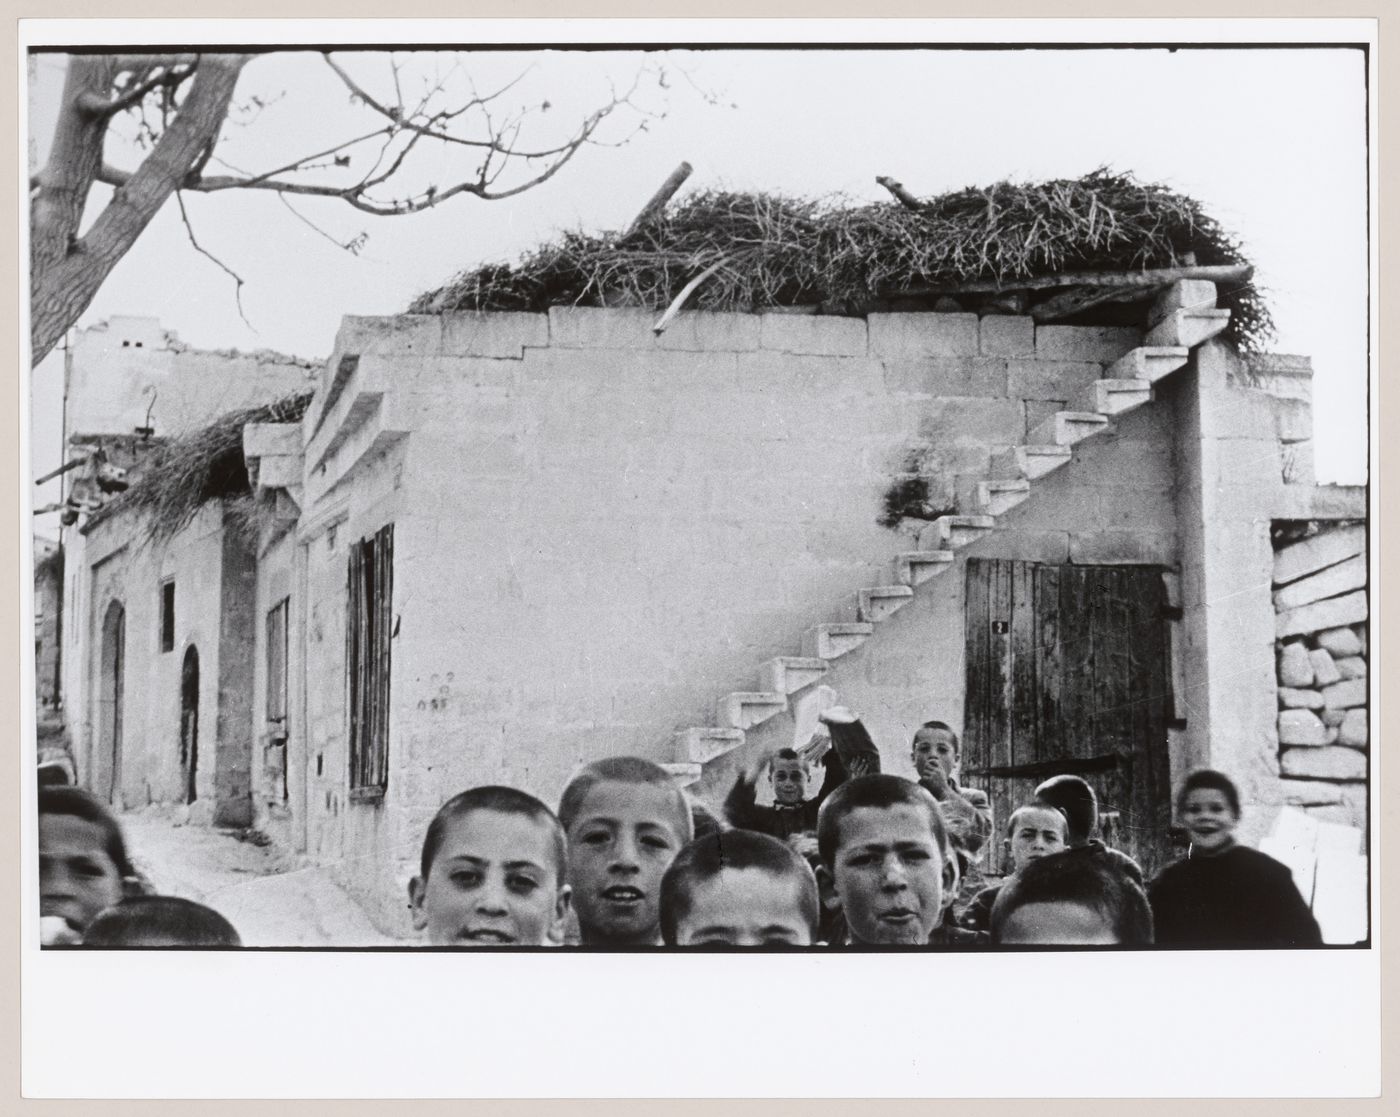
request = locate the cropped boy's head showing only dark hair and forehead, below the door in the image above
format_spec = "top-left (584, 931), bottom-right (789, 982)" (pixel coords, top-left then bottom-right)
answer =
top-left (991, 852), bottom-right (1152, 946)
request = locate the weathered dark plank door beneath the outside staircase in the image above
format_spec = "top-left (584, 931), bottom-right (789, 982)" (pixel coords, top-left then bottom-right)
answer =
top-left (963, 559), bottom-right (1172, 873)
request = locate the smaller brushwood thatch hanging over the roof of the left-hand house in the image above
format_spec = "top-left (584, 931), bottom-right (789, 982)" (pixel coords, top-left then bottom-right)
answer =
top-left (88, 391), bottom-right (312, 542)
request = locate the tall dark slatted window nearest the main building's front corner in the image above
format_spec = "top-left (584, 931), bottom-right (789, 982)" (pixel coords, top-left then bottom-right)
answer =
top-left (346, 524), bottom-right (393, 799)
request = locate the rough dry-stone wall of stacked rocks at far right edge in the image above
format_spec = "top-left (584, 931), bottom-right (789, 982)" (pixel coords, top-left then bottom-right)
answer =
top-left (1273, 522), bottom-right (1369, 829)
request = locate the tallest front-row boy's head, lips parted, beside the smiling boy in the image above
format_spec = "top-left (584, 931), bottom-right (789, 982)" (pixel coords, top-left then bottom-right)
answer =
top-left (559, 756), bottom-right (693, 946)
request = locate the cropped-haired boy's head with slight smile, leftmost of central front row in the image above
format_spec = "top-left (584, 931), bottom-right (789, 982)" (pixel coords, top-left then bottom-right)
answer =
top-left (409, 787), bottom-right (568, 946)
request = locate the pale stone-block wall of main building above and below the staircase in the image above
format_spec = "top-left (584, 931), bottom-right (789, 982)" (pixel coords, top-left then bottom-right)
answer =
top-left (289, 308), bottom-right (1187, 935)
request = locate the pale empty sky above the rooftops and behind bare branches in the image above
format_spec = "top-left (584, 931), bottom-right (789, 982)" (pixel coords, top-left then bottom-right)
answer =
top-left (28, 39), bottom-right (1368, 535)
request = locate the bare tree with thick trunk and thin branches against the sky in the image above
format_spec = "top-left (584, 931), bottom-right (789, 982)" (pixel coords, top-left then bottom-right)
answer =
top-left (29, 53), bottom-right (665, 361)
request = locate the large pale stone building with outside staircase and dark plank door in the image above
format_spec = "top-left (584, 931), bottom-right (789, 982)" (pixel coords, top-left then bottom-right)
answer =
top-left (63, 284), bottom-right (1368, 929)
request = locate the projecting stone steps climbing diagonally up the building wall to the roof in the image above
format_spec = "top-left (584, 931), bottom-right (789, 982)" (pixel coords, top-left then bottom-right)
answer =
top-left (665, 280), bottom-right (1229, 787)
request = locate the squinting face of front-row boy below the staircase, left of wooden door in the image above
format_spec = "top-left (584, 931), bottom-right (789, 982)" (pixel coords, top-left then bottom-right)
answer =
top-left (832, 803), bottom-right (958, 946)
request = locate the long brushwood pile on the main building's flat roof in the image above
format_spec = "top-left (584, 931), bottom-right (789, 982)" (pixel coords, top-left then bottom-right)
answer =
top-left (409, 165), bottom-right (1273, 357)
